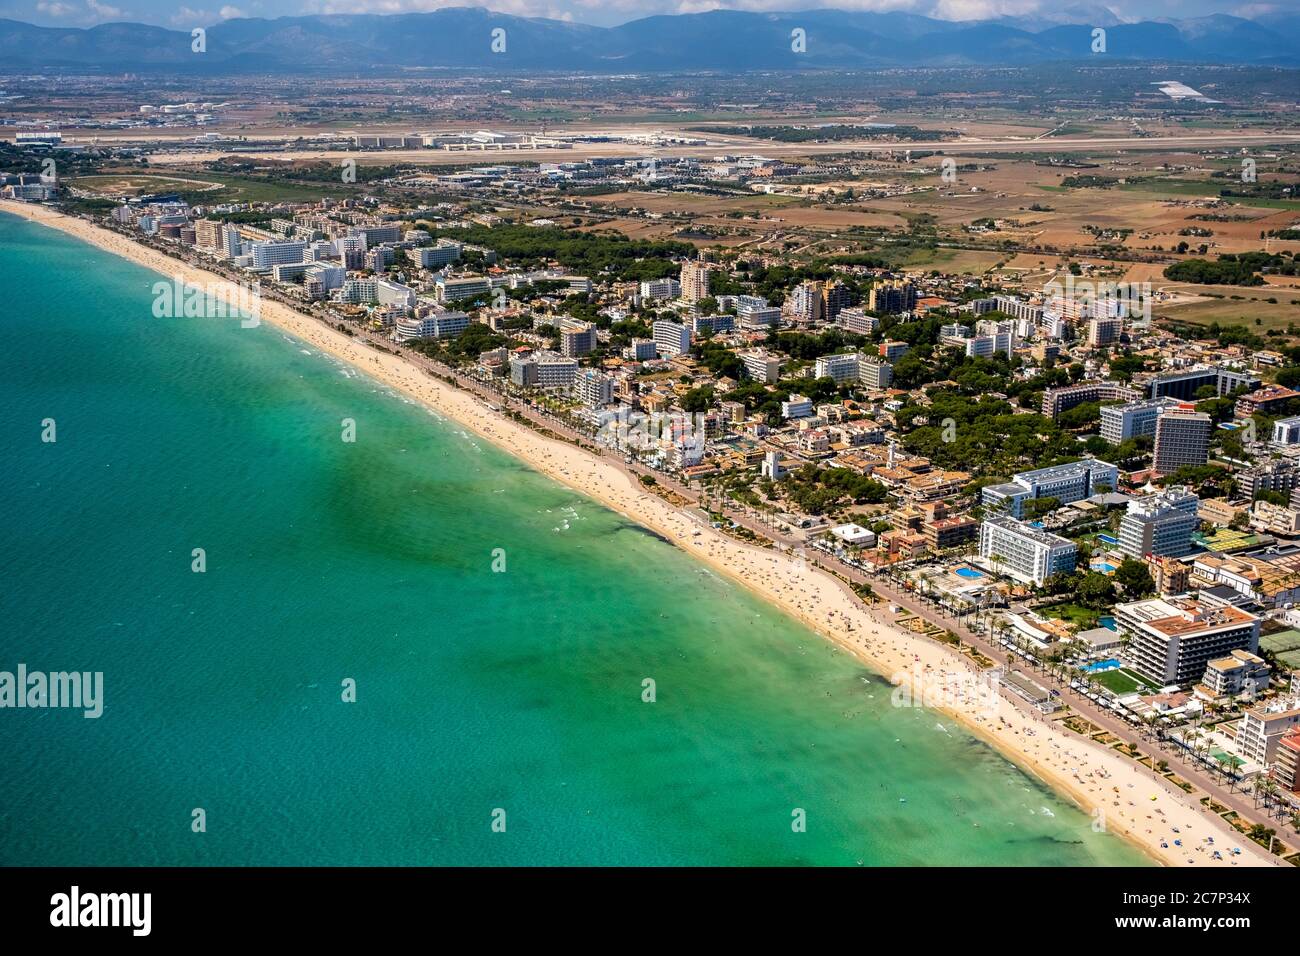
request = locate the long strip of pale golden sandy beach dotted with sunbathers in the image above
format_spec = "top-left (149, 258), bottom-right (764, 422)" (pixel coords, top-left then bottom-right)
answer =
top-left (0, 200), bottom-right (1283, 866)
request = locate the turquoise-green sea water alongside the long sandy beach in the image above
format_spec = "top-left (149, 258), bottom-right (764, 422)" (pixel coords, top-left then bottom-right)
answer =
top-left (0, 215), bottom-right (1145, 865)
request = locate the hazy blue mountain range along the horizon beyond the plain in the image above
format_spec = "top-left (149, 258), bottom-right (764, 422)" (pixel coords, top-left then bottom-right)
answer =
top-left (0, 7), bottom-right (1300, 73)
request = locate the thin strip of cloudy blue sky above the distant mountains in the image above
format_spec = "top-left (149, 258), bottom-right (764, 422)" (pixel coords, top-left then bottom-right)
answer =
top-left (0, 0), bottom-right (1300, 30)
